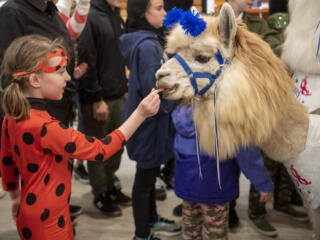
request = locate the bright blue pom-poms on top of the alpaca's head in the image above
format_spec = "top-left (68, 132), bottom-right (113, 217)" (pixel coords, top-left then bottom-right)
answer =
top-left (163, 8), bottom-right (207, 37)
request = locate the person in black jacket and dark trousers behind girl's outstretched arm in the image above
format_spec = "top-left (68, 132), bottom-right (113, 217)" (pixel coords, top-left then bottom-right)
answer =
top-left (78, 0), bottom-right (131, 216)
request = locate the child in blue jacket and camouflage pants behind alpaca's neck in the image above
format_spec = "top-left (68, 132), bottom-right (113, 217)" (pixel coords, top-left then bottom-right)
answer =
top-left (172, 105), bottom-right (274, 240)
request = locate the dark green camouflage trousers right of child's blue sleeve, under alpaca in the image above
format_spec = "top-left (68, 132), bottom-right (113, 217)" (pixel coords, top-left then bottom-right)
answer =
top-left (249, 153), bottom-right (294, 218)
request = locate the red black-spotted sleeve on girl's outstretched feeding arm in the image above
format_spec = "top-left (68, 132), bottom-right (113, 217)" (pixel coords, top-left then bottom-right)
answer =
top-left (40, 120), bottom-right (125, 161)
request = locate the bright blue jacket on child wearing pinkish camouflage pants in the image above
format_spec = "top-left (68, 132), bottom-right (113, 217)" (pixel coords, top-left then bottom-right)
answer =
top-left (172, 106), bottom-right (274, 204)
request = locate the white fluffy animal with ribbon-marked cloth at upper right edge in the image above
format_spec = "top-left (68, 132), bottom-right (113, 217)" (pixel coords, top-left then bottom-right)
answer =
top-left (281, 0), bottom-right (320, 112)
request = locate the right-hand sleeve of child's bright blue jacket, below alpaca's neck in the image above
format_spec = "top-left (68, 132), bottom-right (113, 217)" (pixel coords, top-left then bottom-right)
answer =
top-left (236, 145), bottom-right (274, 192)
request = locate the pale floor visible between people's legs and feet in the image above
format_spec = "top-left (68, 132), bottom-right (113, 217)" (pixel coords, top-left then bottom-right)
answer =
top-left (0, 149), bottom-right (311, 240)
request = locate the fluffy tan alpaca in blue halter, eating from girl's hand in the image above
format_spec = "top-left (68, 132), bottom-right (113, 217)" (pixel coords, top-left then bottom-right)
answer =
top-left (156, 3), bottom-right (320, 239)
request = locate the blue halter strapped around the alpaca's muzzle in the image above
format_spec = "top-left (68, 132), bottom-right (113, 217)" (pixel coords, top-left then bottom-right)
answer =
top-left (174, 49), bottom-right (229, 96)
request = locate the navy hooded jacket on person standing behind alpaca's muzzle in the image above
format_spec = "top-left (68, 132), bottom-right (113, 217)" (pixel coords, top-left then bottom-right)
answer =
top-left (120, 31), bottom-right (174, 168)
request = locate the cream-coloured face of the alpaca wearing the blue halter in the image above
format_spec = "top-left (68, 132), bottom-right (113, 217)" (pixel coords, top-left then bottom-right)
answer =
top-left (156, 36), bottom-right (224, 100)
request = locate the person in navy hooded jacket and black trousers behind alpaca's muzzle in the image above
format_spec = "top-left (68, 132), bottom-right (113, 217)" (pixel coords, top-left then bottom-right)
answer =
top-left (120, 0), bottom-right (181, 240)
